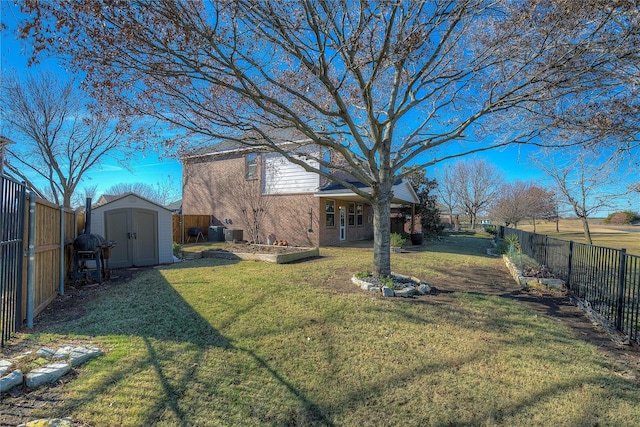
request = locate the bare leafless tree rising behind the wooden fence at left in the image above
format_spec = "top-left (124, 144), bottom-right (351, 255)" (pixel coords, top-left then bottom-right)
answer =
top-left (0, 74), bottom-right (131, 207)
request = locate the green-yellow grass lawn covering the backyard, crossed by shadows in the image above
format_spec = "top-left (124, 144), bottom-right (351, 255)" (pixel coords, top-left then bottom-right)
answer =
top-left (6, 238), bottom-right (640, 426)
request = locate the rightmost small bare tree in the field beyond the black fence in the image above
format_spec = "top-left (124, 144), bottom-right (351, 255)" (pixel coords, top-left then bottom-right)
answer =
top-left (535, 149), bottom-right (629, 244)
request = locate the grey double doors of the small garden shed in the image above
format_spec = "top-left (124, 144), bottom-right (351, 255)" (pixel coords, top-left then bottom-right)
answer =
top-left (105, 208), bottom-right (158, 268)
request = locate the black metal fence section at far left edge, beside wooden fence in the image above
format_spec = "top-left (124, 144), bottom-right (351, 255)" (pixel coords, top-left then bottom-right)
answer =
top-left (0, 176), bottom-right (26, 347)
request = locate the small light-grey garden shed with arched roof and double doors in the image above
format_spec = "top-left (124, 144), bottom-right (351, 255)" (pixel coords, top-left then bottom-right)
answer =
top-left (91, 193), bottom-right (173, 268)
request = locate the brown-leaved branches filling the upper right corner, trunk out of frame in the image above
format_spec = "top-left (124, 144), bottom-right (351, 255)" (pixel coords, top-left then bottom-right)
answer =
top-left (523, 0), bottom-right (640, 153)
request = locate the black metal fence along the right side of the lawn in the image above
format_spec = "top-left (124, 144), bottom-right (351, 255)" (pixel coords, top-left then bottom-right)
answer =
top-left (499, 227), bottom-right (640, 344)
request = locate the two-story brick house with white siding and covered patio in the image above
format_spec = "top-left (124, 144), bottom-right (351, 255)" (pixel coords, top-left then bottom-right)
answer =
top-left (182, 141), bottom-right (418, 246)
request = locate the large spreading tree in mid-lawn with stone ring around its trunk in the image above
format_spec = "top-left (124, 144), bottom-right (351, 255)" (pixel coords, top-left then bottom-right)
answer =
top-left (22, 0), bottom-right (637, 275)
